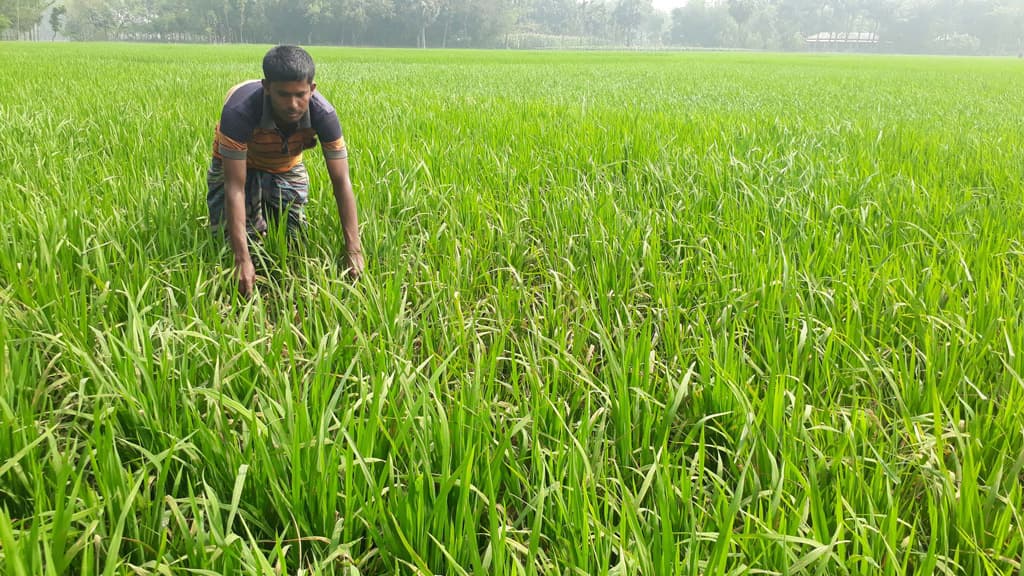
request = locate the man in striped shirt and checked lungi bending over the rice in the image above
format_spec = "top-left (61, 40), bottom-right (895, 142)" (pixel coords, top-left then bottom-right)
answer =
top-left (206, 46), bottom-right (364, 295)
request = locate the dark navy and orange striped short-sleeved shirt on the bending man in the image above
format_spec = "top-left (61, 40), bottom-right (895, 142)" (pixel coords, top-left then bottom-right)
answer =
top-left (213, 80), bottom-right (348, 174)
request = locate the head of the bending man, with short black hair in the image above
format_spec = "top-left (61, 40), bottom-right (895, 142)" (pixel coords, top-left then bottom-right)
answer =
top-left (263, 46), bottom-right (316, 124)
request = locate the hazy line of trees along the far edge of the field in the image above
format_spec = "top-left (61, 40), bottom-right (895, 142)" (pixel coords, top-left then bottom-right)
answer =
top-left (0, 0), bottom-right (1024, 55)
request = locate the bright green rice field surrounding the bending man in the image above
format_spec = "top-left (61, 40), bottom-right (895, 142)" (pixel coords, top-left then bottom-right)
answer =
top-left (0, 43), bottom-right (1024, 576)
